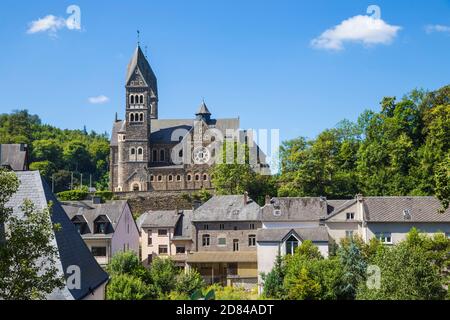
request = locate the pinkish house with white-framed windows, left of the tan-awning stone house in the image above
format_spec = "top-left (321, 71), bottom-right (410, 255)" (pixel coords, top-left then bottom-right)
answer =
top-left (137, 210), bottom-right (192, 268)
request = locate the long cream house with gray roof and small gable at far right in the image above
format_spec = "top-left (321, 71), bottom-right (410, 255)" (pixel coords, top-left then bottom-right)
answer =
top-left (325, 195), bottom-right (450, 245)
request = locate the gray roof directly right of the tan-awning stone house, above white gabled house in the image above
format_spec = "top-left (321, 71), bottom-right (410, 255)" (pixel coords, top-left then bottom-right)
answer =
top-left (261, 198), bottom-right (328, 222)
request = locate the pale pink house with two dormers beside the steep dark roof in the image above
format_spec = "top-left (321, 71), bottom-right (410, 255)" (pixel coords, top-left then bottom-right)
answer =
top-left (63, 197), bottom-right (139, 266)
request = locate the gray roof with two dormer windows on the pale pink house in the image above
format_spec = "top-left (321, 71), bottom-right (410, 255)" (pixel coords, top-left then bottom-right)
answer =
top-left (62, 200), bottom-right (128, 238)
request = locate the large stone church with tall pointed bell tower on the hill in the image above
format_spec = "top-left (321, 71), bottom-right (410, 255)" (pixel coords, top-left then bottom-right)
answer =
top-left (110, 45), bottom-right (267, 192)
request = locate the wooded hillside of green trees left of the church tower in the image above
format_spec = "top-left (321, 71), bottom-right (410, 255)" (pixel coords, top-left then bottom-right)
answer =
top-left (0, 110), bottom-right (109, 192)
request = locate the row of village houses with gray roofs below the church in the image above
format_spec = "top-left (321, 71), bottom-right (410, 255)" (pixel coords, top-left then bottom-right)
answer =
top-left (0, 144), bottom-right (450, 299)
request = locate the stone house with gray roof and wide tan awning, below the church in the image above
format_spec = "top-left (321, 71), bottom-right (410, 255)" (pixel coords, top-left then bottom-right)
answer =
top-left (187, 194), bottom-right (261, 288)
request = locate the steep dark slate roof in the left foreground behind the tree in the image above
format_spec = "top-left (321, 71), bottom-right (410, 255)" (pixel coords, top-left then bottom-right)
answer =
top-left (7, 171), bottom-right (109, 300)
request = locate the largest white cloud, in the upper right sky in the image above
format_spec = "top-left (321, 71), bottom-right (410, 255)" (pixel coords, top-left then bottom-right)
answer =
top-left (311, 15), bottom-right (401, 51)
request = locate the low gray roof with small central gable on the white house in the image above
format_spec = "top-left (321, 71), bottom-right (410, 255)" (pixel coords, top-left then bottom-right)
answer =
top-left (256, 226), bottom-right (328, 242)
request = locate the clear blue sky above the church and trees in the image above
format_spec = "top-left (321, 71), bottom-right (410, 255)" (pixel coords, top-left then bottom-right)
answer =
top-left (0, 0), bottom-right (450, 139)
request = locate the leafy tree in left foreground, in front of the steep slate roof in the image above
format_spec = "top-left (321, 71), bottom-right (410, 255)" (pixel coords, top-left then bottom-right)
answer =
top-left (0, 170), bottom-right (64, 300)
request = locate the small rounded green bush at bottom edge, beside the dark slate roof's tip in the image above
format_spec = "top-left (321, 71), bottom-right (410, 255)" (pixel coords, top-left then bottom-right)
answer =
top-left (106, 274), bottom-right (154, 300)
